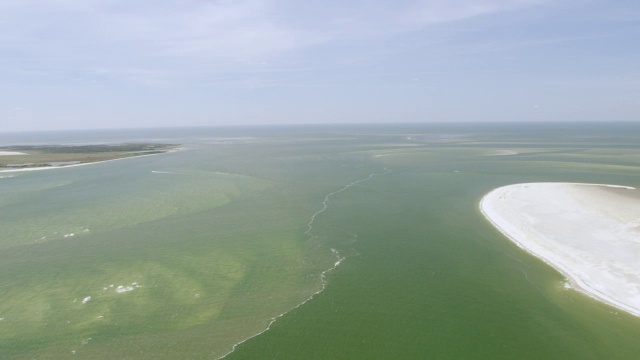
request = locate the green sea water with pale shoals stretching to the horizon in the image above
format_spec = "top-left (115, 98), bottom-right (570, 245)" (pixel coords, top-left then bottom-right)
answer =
top-left (0, 123), bottom-right (640, 359)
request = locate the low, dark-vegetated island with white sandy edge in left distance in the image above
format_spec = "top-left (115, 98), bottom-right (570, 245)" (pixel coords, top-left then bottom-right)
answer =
top-left (0, 143), bottom-right (177, 172)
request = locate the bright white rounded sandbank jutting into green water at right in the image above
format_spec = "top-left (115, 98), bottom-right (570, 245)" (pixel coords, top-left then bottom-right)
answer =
top-left (480, 183), bottom-right (640, 316)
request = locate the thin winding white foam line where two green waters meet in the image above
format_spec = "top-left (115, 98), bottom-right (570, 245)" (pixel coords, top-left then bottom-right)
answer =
top-left (216, 168), bottom-right (391, 360)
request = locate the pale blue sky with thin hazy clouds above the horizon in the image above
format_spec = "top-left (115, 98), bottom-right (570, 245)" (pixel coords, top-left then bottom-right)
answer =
top-left (0, 0), bottom-right (640, 132)
